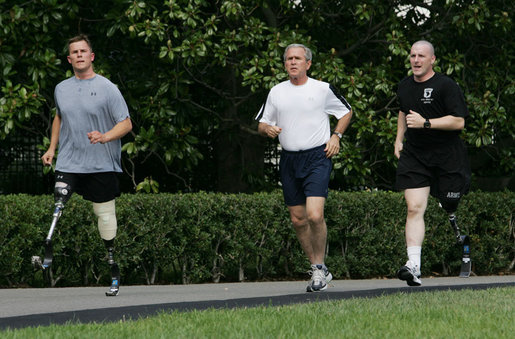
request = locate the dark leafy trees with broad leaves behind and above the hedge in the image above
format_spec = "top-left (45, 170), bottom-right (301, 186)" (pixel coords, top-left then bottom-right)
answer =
top-left (0, 0), bottom-right (515, 192)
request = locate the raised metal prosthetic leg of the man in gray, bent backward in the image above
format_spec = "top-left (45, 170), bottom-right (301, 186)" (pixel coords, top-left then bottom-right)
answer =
top-left (32, 182), bottom-right (72, 270)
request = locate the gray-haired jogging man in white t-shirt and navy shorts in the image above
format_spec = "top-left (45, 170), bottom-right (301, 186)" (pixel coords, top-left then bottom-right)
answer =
top-left (256, 44), bottom-right (352, 292)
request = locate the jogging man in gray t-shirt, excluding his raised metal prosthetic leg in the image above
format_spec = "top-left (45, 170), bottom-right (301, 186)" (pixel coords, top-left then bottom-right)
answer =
top-left (41, 35), bottom-right (132, 295)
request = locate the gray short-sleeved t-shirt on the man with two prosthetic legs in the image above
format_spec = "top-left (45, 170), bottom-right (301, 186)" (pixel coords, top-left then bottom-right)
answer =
top-left (54, 74), bottom-right (129, 173)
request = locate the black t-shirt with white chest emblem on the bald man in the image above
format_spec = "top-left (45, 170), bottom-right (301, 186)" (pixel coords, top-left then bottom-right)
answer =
top-left (397, 73), bottom-right (469, 148)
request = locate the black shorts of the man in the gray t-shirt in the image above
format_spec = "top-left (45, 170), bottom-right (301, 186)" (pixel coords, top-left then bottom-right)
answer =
top-left (55, 171), bottom-right (120, 203)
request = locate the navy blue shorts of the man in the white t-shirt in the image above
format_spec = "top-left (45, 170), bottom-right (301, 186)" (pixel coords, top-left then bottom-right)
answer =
top-left (279, 145), bottom-right (333, 206)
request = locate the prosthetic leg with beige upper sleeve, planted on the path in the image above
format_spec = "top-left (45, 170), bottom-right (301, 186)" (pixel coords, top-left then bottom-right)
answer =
top-left (93, 200), bottom-right (120, 297)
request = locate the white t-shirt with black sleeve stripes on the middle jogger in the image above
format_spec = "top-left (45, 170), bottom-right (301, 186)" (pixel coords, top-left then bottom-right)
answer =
top-left (256, 78), bottom-right (351, 151)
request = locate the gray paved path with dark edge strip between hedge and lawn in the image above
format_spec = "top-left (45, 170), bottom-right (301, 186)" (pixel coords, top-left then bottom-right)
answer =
top-left (0, 275), bottom-right (515, 330)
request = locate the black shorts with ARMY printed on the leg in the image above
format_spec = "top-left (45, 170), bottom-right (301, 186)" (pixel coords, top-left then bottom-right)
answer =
top-left (395, 140), bottom-right (471, 201)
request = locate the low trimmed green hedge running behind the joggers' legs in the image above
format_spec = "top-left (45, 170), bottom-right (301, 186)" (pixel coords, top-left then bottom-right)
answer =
top-left (0, 192), bottom-right (515, 286)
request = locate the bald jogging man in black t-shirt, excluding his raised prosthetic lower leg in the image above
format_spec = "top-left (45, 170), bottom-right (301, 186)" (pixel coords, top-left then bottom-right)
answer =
top-left (395, 40), bottom-right (470, 286)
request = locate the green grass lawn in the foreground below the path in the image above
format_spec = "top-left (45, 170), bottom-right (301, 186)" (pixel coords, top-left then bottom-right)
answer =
top-left (0, 287), bottom-right (515, 339)
